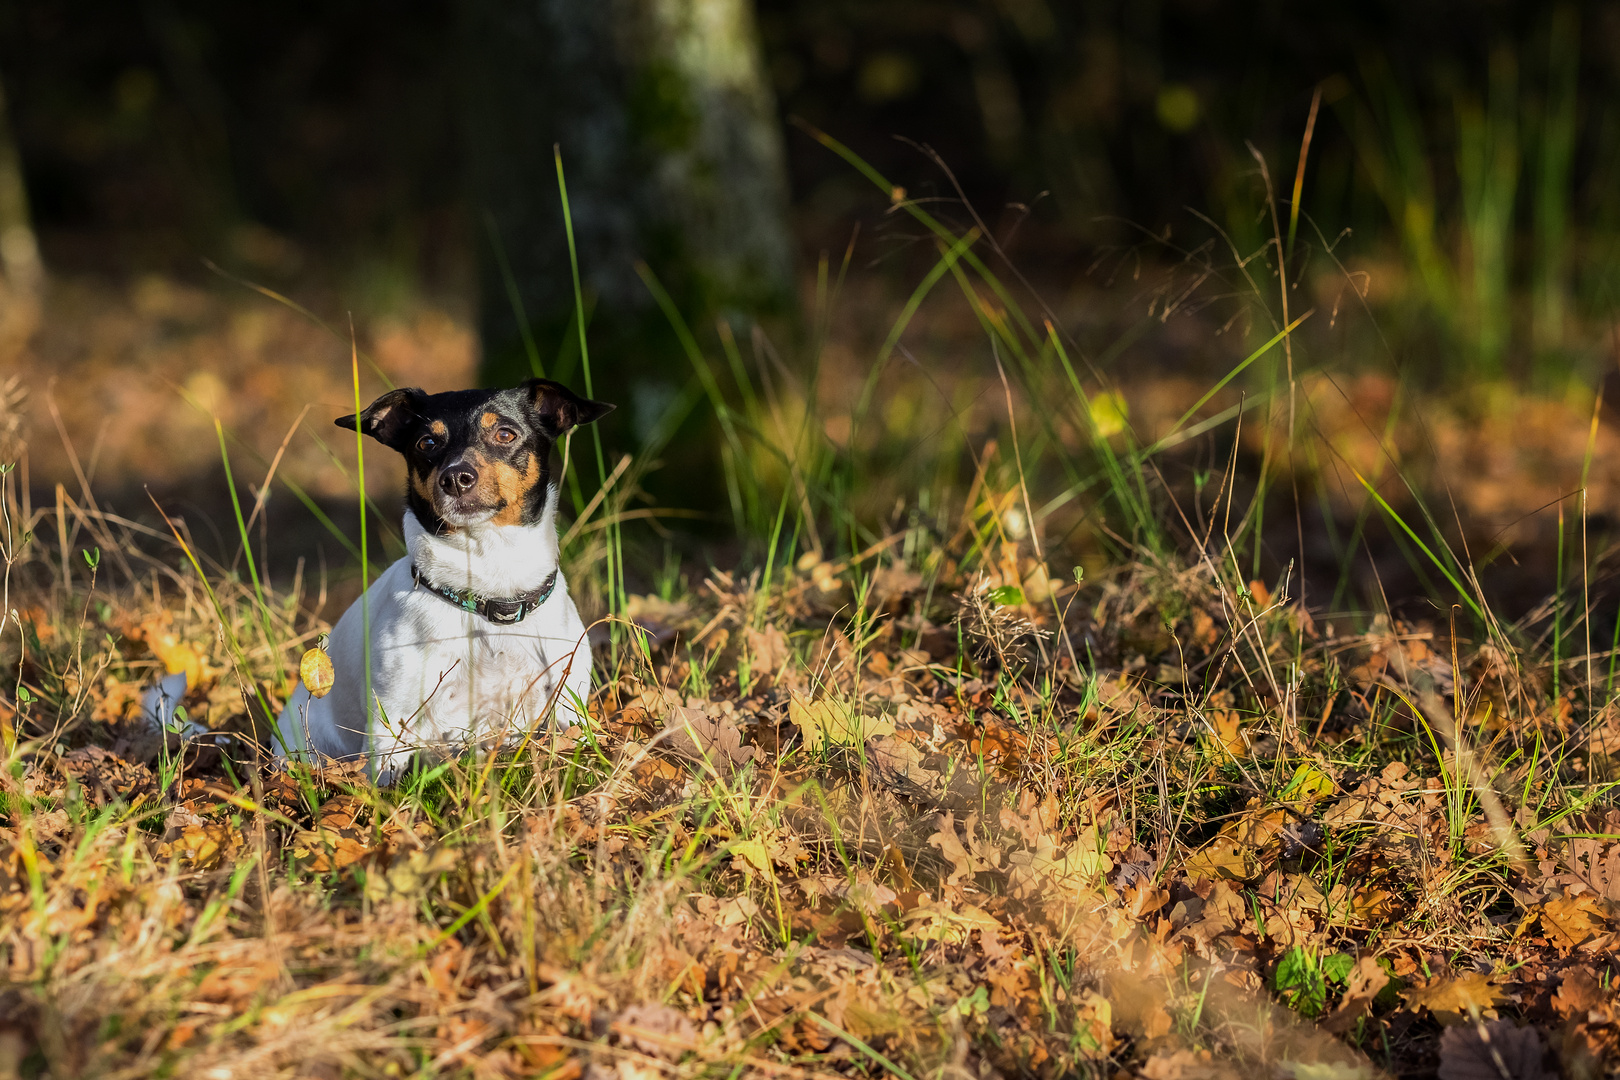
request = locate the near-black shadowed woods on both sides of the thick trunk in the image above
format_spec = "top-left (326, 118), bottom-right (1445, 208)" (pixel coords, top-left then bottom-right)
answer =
top-left (0, 0), bottom-right (1620, 338)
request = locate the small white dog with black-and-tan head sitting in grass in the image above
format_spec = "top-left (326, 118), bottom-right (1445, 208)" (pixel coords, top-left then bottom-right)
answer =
top-left (275, 379), bottom-right (612, 784)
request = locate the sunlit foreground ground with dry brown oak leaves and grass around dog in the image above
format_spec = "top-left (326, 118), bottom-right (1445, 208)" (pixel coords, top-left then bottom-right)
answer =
top-left (0, 534), bottom-right (1620, 1080)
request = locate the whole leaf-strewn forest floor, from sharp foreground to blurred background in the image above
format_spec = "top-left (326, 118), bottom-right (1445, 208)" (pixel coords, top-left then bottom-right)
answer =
top-left (0, 255), bottom-right (1620, 1080)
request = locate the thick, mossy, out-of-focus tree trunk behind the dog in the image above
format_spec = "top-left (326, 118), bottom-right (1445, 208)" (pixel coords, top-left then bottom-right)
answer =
top-left (460, 0), bottom-right (794, 465)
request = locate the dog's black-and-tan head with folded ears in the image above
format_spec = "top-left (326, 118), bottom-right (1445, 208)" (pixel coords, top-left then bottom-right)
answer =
top-left (337, 379), bottom-right (612, 533)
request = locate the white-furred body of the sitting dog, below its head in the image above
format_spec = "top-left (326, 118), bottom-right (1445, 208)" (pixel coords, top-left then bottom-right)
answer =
top-left (275, 486), bottom-right (591, 784)
